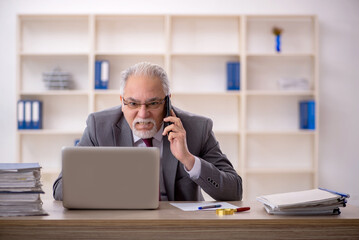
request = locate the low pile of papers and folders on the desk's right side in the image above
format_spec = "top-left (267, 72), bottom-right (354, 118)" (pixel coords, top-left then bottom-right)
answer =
top-left (257, 188), bottom-right (349, 215)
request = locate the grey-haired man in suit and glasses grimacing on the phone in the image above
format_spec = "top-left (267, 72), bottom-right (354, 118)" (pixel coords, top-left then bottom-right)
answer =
top-left (53, 62), bottom-right (242, 201)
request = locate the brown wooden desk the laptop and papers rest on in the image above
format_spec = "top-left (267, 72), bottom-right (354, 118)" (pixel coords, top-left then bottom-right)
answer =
top-left (0, 200), bottom-right (359, 240)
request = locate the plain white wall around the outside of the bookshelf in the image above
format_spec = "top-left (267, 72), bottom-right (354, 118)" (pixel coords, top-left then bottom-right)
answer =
top-left (0, 0), bottom-right (359, 206)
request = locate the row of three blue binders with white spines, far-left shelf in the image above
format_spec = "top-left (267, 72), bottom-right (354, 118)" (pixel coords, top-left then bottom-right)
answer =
top-left (17, 100), bottom-right (42, 129)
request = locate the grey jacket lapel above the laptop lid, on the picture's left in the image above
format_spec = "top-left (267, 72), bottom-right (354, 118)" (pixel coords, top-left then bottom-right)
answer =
top-left (112, 114), bottom-right (133, 147)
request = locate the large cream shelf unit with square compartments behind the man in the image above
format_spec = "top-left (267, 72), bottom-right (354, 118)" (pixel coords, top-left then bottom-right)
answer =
top-left (16, 14), bottom-right (319, 200)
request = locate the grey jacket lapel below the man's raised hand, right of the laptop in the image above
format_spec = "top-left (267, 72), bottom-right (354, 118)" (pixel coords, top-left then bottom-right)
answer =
top-left (162, 136), bottom-right (178, 201)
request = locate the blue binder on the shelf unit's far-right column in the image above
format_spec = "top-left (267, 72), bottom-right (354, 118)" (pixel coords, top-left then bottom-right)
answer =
top-left (299, 100), bottom-right (315, 130)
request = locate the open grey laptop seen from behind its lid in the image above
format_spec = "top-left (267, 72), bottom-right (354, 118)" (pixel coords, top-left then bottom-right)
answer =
top-left (62, 147), bottom-right (160, 209)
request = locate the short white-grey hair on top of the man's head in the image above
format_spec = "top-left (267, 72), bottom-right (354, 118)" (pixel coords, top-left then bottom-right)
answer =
top-left (120, 62), bottom-right (170, 96)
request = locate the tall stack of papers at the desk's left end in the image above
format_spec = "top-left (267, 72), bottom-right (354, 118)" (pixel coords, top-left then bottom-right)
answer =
top-left (0, 163), bottom-right (47, 217)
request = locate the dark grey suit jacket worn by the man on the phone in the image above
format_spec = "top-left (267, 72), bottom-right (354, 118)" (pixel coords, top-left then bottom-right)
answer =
top-left (53, 107), bottom-right (242, 201)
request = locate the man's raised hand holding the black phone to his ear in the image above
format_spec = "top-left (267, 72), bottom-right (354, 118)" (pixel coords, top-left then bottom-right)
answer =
top-left (162, 109), bottom-right (195, 171)
